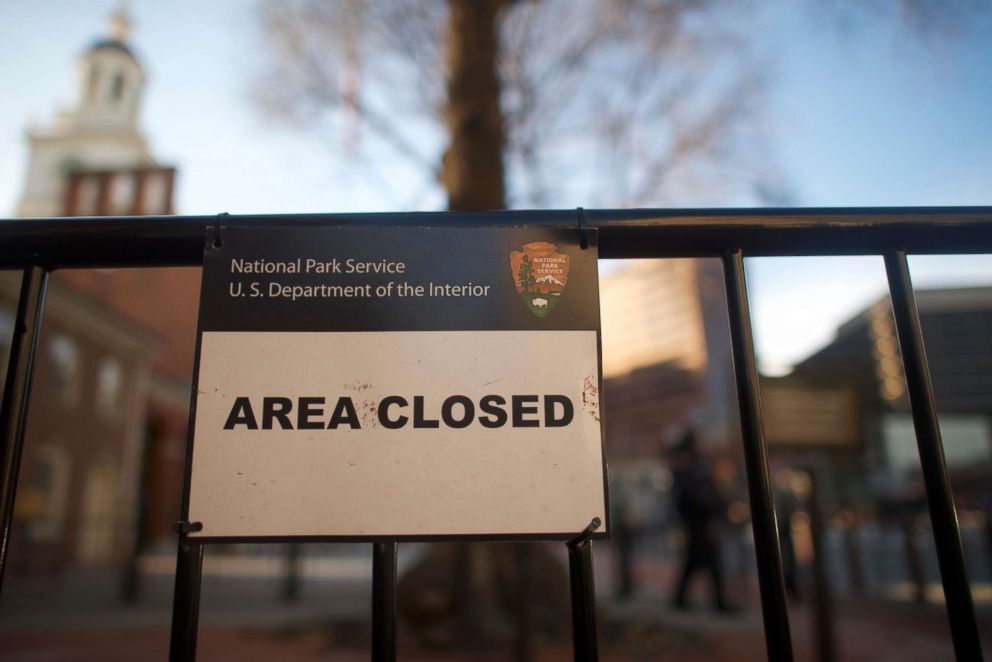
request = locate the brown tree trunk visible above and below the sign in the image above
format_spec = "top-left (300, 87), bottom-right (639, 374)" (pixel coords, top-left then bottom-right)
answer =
top-left (398, 0), bottom-right (568, 662)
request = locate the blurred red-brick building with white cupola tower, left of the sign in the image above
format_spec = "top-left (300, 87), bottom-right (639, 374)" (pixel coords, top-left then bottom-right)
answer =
top-left (0, 11), bottom-right (199, 571)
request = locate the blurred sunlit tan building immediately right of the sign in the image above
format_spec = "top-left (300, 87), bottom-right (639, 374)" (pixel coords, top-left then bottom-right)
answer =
top-left (600, 259), bottom-right (740, 467)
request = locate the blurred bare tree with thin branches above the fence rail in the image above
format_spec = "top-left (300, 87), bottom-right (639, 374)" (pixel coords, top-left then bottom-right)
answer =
top-left (259, 0), bottom-right (767, 209)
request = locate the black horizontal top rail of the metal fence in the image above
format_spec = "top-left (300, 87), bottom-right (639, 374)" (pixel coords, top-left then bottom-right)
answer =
top-left (0, 207), bottom-right (992, 269)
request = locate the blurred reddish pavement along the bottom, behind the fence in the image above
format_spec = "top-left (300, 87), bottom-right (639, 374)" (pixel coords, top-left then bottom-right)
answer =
top-left (0, 546), bottom-right (992, 662)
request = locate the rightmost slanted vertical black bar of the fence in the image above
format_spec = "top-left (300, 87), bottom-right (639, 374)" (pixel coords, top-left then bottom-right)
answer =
top-left (885, 250), bottom-right (982, 660)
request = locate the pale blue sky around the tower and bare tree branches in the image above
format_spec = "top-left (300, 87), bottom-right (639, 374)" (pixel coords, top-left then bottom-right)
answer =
top-left (0, 0), bottom-right (992, 370)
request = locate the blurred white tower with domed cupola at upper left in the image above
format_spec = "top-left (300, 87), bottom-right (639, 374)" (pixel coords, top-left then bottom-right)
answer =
top-left (18, 9), bottom-right (155, 216)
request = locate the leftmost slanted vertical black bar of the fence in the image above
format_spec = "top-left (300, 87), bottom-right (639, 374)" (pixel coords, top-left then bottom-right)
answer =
top-left (0, 267), bottom-right (48, 592)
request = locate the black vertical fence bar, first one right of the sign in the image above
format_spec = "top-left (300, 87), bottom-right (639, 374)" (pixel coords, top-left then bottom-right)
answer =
top-left (723, 250), bottom-right (792, 662)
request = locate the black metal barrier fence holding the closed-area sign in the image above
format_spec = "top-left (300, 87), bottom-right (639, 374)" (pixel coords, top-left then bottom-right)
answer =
top-left (0, 207), bottom-right (992, 661)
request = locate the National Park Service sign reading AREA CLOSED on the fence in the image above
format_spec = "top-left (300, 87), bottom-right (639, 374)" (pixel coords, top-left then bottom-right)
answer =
top-left (188, 226), bottom-right (607, 540)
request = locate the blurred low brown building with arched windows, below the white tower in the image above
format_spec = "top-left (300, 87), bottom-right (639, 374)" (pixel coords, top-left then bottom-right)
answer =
top-left (0, 272), bottom-right (161, 574)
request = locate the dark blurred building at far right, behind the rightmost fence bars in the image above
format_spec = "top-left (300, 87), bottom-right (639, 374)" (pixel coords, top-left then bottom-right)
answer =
top-left (762, 287), bottom-right (992, 500)
